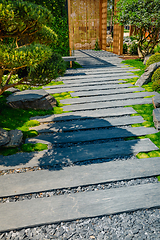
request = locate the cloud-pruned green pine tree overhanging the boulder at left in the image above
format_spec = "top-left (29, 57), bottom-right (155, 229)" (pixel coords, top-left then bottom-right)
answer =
top-left (0, 0), bottom-right (65, 95)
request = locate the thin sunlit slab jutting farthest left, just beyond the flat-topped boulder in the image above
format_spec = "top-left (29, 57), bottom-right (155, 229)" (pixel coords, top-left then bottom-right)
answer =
top-left (46, 83), bottom-right (133, 94)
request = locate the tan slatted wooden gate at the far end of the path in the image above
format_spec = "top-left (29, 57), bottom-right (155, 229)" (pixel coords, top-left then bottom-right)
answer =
top-left (68, 0), bottom-right (107, 50)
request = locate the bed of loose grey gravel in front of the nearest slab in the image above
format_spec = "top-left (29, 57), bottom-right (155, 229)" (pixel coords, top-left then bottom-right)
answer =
top-left (0, 208), bottom-right (160, 240)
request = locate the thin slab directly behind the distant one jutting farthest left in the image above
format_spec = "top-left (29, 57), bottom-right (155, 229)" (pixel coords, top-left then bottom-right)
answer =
top-left (60, 75), bottom-right (137, 85)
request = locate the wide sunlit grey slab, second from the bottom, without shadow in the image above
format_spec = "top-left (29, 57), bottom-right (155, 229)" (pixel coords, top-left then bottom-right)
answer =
top-left (0, 157), bottom-right (160, 197)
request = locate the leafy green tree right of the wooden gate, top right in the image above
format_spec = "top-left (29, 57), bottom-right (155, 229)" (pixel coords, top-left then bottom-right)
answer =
top-left (115, 0), bottom-right (160, 57)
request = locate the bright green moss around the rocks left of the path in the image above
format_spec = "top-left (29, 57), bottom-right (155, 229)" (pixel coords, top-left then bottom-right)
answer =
top-left (0, 92), bottom-right (72, 156)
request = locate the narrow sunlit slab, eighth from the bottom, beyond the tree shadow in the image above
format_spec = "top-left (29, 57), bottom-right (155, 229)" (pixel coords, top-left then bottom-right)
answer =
top-left (60, 92), bottom-right (154, 104)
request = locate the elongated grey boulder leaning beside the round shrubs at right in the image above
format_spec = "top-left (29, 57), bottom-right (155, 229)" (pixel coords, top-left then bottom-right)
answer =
top-left (135, 62), bottom-right (160, 87)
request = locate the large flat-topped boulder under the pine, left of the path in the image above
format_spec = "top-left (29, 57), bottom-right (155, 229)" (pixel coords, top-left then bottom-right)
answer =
top-left (7, 89), bottom-right (57, 110)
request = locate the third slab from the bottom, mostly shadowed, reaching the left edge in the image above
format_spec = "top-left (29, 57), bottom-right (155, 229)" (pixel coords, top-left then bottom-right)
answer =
top-left (0, 138), bottom-right (159, 170)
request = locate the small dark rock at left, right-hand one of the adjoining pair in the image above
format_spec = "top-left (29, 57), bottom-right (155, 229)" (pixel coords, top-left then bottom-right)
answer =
top-left (5, 129), bottom-right (23, 147)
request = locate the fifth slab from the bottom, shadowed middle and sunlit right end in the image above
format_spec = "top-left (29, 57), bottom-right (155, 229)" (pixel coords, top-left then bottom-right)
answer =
top-left (30, 116), bottom-right (143, 133)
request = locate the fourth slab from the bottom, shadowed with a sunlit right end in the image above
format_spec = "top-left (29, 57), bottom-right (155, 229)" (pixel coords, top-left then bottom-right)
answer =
top-left (25, 127), bottom-right (157, 144)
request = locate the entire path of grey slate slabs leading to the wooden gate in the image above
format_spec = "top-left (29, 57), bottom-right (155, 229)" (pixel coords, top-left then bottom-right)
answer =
top-left (0, 50), bottom-right (160, 236)
